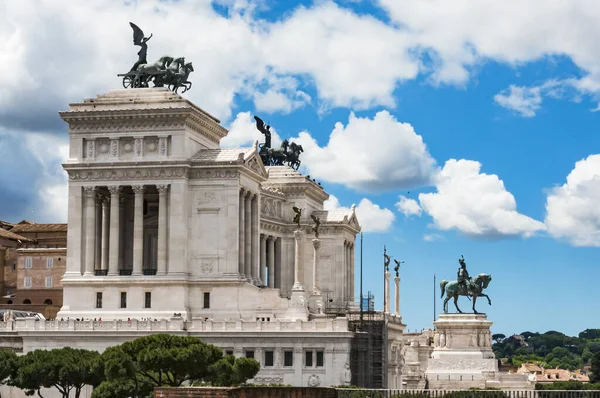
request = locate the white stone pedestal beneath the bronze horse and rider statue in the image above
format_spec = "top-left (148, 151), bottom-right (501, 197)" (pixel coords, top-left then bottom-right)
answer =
top-left (425, 314), bottom-right (530, 390)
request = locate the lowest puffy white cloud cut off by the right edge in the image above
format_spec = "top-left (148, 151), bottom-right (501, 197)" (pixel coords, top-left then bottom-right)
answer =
top-left (546, 154), bottom-right (600, 247)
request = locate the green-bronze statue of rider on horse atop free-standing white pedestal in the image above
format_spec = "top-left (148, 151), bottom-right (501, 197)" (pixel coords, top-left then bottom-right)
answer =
top-left (440, 256), bottom-right (492, 314)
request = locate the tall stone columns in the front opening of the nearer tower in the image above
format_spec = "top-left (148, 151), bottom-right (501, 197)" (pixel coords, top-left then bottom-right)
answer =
top-left (82, 185), bottom-right (169, 276)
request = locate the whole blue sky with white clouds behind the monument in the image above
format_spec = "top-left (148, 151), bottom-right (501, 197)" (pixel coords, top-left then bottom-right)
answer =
top-left (0, 0), bottom-right (600, 334)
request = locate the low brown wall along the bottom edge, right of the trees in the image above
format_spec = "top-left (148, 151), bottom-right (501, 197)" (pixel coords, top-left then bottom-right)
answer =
top-left (154, 387), bottom-right (336, 398)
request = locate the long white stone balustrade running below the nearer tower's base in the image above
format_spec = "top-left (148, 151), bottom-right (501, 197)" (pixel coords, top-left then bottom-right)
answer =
top-left (0, 317), bottom-right (348, 332)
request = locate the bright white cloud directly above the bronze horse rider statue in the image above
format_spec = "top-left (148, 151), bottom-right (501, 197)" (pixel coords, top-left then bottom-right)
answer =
top-left (419, 159), bottom-right (545, 238)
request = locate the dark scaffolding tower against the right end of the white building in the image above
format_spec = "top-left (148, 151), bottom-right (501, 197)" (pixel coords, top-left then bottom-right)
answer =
top-left (347, 292), bottom-right (387, 388)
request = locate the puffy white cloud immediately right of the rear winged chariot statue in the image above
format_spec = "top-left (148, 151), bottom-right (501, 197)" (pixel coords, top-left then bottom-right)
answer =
top-left (292, 111), bottom-right (435, 191)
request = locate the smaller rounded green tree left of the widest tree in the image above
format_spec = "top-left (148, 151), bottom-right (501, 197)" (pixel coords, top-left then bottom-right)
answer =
top-left (9, 347), bottom-right (103, 398)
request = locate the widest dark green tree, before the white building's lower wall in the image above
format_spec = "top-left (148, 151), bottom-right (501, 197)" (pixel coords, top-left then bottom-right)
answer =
top-left (92, 334), bottom-right (259, 398)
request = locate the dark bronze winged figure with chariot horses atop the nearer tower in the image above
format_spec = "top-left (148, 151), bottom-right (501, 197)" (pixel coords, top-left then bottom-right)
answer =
top-left (117, 22), bottom-right (194, 93)
